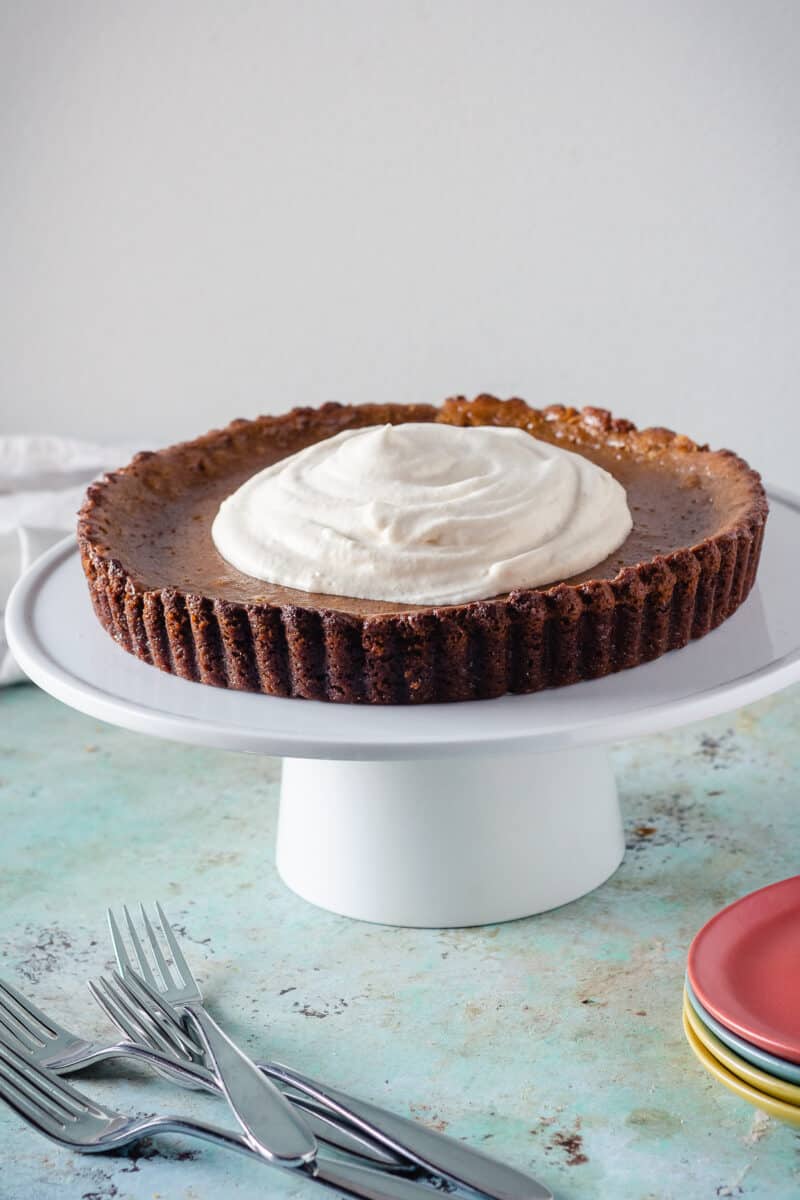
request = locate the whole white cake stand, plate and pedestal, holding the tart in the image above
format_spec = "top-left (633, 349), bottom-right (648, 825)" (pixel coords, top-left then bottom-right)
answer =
top-left (7, 490), bottom-right (800, 926)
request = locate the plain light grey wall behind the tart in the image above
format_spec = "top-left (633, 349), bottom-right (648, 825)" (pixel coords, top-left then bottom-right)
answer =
top-left (0, 0), bottom-right (800, 486)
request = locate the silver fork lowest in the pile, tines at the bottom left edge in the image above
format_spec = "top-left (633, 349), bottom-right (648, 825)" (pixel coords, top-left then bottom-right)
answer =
top-left (0, 1032), bottom-right (443, 1200)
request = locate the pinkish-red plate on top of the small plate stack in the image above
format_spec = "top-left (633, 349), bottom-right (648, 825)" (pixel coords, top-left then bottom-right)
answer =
top-left (688, 875), bottom-right (800, 1062)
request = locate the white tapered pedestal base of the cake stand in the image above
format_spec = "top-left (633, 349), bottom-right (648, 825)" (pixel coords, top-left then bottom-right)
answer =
top-left (277, 748), bottom-right (625, 928)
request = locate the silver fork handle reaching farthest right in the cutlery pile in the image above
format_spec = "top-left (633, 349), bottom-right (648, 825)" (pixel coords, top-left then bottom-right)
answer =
top-left (259, 1062), bottom-right (553, 1200)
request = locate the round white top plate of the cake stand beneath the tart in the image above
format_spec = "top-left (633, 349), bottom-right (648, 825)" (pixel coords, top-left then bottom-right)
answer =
top-left (6, 492), bottom-right (800, 760)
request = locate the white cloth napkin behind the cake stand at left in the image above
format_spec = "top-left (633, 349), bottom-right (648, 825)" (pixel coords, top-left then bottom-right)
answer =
top-left (0, 433), bottom-right (140, 686)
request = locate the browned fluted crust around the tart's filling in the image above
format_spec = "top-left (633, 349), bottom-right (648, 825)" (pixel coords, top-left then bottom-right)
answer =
top-left (78, 396), bottom-right (769, 704)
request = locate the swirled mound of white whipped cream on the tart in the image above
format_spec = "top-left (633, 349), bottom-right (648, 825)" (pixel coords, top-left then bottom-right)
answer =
top-left (211, 424), bottom-right (632, 605)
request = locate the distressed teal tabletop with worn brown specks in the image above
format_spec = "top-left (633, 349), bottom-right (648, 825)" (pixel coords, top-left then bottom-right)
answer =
top-left (0, 686), bottom-right (800, 1200)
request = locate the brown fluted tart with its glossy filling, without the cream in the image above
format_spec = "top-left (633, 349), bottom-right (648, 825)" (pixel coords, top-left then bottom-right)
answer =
top-left (78, 396), bottom-right (768, 704)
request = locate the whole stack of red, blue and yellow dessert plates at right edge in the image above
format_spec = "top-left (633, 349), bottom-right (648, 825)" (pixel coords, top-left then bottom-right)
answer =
top-left (684, 876), bottom-right (800, 1126)
